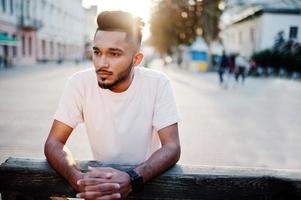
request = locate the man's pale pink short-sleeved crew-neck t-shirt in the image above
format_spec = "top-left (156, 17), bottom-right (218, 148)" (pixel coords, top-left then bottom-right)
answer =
top-left (54, 67), bottom-right (179, 164)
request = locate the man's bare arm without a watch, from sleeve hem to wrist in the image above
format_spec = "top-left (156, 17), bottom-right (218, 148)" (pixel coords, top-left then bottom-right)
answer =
top-left (44, 120), bottom-right (83, 191)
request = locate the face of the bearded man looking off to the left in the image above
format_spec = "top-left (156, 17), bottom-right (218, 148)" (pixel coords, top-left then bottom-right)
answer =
top-left (93, 31), bottom-right (135, 91)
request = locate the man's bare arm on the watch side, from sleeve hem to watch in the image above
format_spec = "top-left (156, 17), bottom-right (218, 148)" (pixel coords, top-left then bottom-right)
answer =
top-left (134, 123), bottom-right (181, 182)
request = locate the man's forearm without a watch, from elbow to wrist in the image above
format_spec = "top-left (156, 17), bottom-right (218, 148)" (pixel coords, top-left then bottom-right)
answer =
top-left (44, 140), bottom-right (82, 190)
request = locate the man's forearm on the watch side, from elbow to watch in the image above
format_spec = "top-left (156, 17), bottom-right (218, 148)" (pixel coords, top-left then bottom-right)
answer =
top-left (135, 143), bottom-right (181, 182)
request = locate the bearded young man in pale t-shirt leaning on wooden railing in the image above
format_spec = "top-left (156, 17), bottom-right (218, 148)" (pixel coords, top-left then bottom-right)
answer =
top-left (45, 11), bottom-right (180, 199)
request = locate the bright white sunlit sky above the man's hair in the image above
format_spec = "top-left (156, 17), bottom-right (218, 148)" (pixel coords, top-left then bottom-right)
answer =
top-left (83, 0), bottom-right (154, 40)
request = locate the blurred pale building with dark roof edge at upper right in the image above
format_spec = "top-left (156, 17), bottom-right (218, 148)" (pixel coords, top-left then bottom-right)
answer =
top-left (220, 1), bottom-right (301, 57)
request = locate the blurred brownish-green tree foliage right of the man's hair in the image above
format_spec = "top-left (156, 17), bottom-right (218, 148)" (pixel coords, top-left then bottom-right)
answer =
top-left (150, 0), bottom-right (221, 54)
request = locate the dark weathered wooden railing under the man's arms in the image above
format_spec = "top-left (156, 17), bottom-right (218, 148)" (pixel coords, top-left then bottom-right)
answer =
top-left (0, 158), bottom-right (301, 200)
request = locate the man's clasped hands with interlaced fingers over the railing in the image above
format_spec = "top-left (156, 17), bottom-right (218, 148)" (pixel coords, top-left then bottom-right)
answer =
top-left (76, 167), bottom-right (132, 200)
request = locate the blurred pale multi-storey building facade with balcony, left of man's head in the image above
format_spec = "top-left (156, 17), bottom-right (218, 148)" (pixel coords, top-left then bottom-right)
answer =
top-left (0, 0), bottom-right (85, 64)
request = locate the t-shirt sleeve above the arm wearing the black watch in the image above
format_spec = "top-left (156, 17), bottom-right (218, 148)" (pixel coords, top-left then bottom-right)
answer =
top-left (153, 80), bottom-right (180, 131)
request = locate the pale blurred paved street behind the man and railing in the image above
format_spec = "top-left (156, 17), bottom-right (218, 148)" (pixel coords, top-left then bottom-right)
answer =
top-left (0, 62), bottom-right (301, 168)
